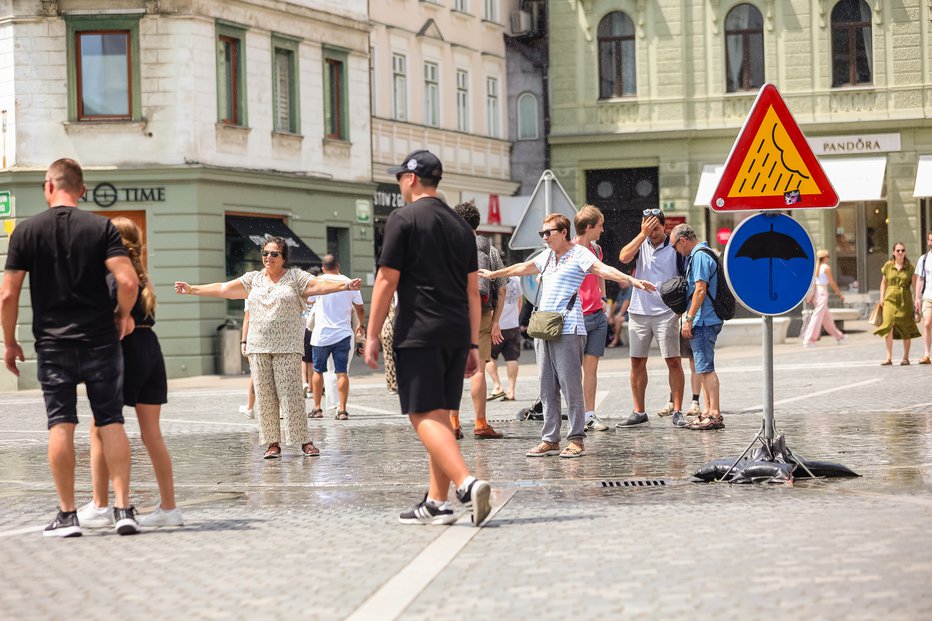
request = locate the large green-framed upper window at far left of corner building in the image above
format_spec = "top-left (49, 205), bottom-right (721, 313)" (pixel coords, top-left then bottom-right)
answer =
top-left (66, 15), bottom-right (142, 121)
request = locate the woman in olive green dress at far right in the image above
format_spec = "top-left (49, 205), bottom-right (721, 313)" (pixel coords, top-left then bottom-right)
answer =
top-left (874, 243), bottom-right (920, 366)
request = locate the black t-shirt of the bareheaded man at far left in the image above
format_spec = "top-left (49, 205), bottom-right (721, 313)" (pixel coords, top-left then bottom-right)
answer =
top-left (6, 207), bottom-right (129, 345)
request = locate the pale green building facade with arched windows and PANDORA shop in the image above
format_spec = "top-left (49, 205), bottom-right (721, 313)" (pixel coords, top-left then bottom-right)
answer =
top-left (549, 0), bottom-right (932, 299)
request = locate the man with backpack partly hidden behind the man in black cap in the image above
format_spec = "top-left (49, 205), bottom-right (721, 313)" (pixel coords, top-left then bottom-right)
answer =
top-left (450, 201), bottom-right (508, 440)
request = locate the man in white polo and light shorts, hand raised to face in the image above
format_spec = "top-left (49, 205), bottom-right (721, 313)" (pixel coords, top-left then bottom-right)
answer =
top-left (616, 209), bottom-right (686, 429)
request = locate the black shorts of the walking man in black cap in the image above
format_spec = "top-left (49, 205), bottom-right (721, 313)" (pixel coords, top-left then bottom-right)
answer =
top-left (395, 347), bottom-right (469, 414)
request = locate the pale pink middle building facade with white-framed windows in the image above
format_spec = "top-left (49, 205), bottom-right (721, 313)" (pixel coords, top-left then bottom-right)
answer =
top-left (369, 0), bottom-right (518, 254)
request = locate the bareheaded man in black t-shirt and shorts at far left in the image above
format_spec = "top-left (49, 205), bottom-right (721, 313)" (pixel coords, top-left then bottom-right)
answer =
top-left (0, 159), bottom-right (139, 537)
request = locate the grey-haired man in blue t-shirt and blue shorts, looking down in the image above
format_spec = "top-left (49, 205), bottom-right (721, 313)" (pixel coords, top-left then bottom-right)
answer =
top-left (670, 224), bottom-right (725, 430)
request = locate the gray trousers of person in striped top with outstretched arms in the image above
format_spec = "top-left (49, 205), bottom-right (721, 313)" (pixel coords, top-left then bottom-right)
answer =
top-left (534, 334), bottom-right (586, 442)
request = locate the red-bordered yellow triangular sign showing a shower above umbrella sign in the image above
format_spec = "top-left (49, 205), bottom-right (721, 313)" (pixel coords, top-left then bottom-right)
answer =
top-left (711, 84), bottom-right (838, 211)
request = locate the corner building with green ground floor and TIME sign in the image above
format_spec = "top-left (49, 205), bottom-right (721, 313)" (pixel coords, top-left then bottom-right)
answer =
top-left (0, 0), bottom-right (374, 389)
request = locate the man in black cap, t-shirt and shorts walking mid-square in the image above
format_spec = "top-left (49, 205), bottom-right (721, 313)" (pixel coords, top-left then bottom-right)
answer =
top-left (366, 151), bottom-right (491, 526)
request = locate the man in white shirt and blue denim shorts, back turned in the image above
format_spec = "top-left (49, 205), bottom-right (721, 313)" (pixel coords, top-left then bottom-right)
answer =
top-left (308, 254), bottom-right (366, 420)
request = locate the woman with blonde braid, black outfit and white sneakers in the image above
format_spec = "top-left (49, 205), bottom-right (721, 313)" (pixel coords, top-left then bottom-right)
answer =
top-left (78, 217), bottom-right (184, 528)
